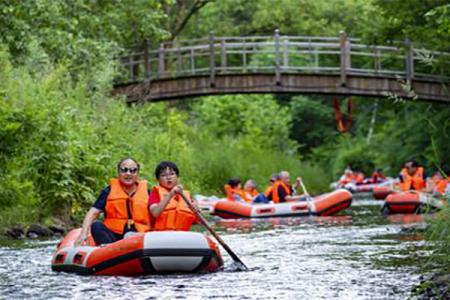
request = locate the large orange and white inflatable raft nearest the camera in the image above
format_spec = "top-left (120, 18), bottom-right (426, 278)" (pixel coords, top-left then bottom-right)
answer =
top-left (52, 229), bottom-right (223, 276)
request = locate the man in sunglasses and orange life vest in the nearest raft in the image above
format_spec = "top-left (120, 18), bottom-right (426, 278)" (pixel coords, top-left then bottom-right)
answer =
top-left (75, 157), bottom-right (150, 246)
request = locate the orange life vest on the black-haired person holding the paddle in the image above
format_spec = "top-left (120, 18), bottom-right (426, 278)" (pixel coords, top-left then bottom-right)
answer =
top-left (150, 186), bottom-right (197, 231)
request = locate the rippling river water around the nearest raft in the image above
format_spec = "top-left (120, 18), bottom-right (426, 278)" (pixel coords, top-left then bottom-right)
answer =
top-left (0, 200), bottom-right (429, 299)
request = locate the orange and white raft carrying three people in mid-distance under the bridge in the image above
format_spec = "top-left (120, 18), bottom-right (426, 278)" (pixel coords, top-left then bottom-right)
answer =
top-left (212, 189), bottom-right (352, 219)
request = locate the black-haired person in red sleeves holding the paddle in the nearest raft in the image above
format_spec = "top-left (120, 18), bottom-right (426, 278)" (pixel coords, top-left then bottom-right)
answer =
top-left (148, 161), bottom-right (197, 231)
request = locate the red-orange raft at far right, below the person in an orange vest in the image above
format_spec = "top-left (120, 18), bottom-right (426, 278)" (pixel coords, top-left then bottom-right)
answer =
top-left (381, 192), bottom-right (445, 214)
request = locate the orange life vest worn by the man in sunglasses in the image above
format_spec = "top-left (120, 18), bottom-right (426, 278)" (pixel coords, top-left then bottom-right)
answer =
top-left (103, 178), bottom-right (150, 234)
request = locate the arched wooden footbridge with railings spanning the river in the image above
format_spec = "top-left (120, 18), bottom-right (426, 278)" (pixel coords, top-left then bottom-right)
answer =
top-left (114, 30), bottom-right (450, 103)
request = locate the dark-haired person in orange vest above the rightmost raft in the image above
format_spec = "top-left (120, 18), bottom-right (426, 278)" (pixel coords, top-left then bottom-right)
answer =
top-left (398, 159), bottom-right (426, 191)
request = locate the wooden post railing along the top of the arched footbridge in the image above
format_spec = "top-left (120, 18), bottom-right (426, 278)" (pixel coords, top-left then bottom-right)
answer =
top-left (121, 30), bottom-right (450, 84)
